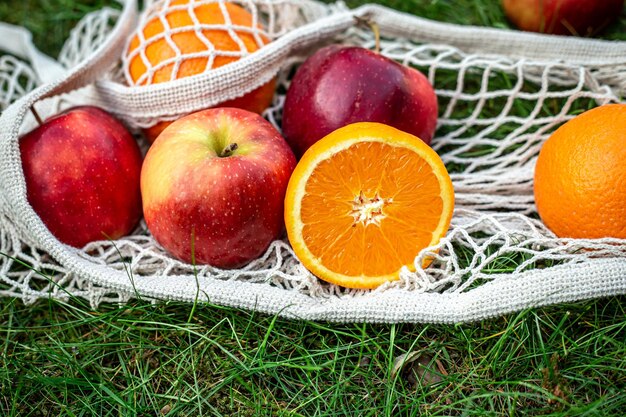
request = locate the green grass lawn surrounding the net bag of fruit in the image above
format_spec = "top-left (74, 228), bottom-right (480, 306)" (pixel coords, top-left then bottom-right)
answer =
top-left (0, 0), bottom-right (626, 417)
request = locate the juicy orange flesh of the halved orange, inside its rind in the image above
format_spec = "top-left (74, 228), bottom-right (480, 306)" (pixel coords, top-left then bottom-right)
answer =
top-left (300, 142), bottom-right (443, 276)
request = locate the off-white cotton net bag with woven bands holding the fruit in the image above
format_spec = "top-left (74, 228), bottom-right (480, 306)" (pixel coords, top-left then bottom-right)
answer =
top-left (0, 0), bottom-right (626, 323)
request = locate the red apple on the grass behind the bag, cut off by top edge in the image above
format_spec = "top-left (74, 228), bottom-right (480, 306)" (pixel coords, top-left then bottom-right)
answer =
top-left (502, 0), bottom-right (624, 36)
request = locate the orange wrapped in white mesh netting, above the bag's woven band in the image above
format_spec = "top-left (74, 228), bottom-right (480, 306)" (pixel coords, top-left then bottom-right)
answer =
top-left (123, 0), bottom-right (270, 85)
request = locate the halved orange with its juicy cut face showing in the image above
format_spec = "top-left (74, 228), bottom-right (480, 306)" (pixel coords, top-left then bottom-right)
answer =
top-left (285, 123), bottom-right (454, 289)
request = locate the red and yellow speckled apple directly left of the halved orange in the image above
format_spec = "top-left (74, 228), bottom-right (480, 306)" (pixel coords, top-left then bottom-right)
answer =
top-left (141, 108), bottom-right (296, 269)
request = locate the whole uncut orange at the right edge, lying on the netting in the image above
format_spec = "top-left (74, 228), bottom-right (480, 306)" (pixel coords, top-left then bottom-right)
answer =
top-left (535, 104), bottom-right (626, 239)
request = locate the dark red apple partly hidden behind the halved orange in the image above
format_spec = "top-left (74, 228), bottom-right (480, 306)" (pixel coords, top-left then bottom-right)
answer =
top-left (282, 45), bottom-right (438, 157)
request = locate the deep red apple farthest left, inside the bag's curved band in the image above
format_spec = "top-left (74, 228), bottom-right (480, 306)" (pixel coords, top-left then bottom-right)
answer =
top-left (20, 107), bottom-right (141, 247)
